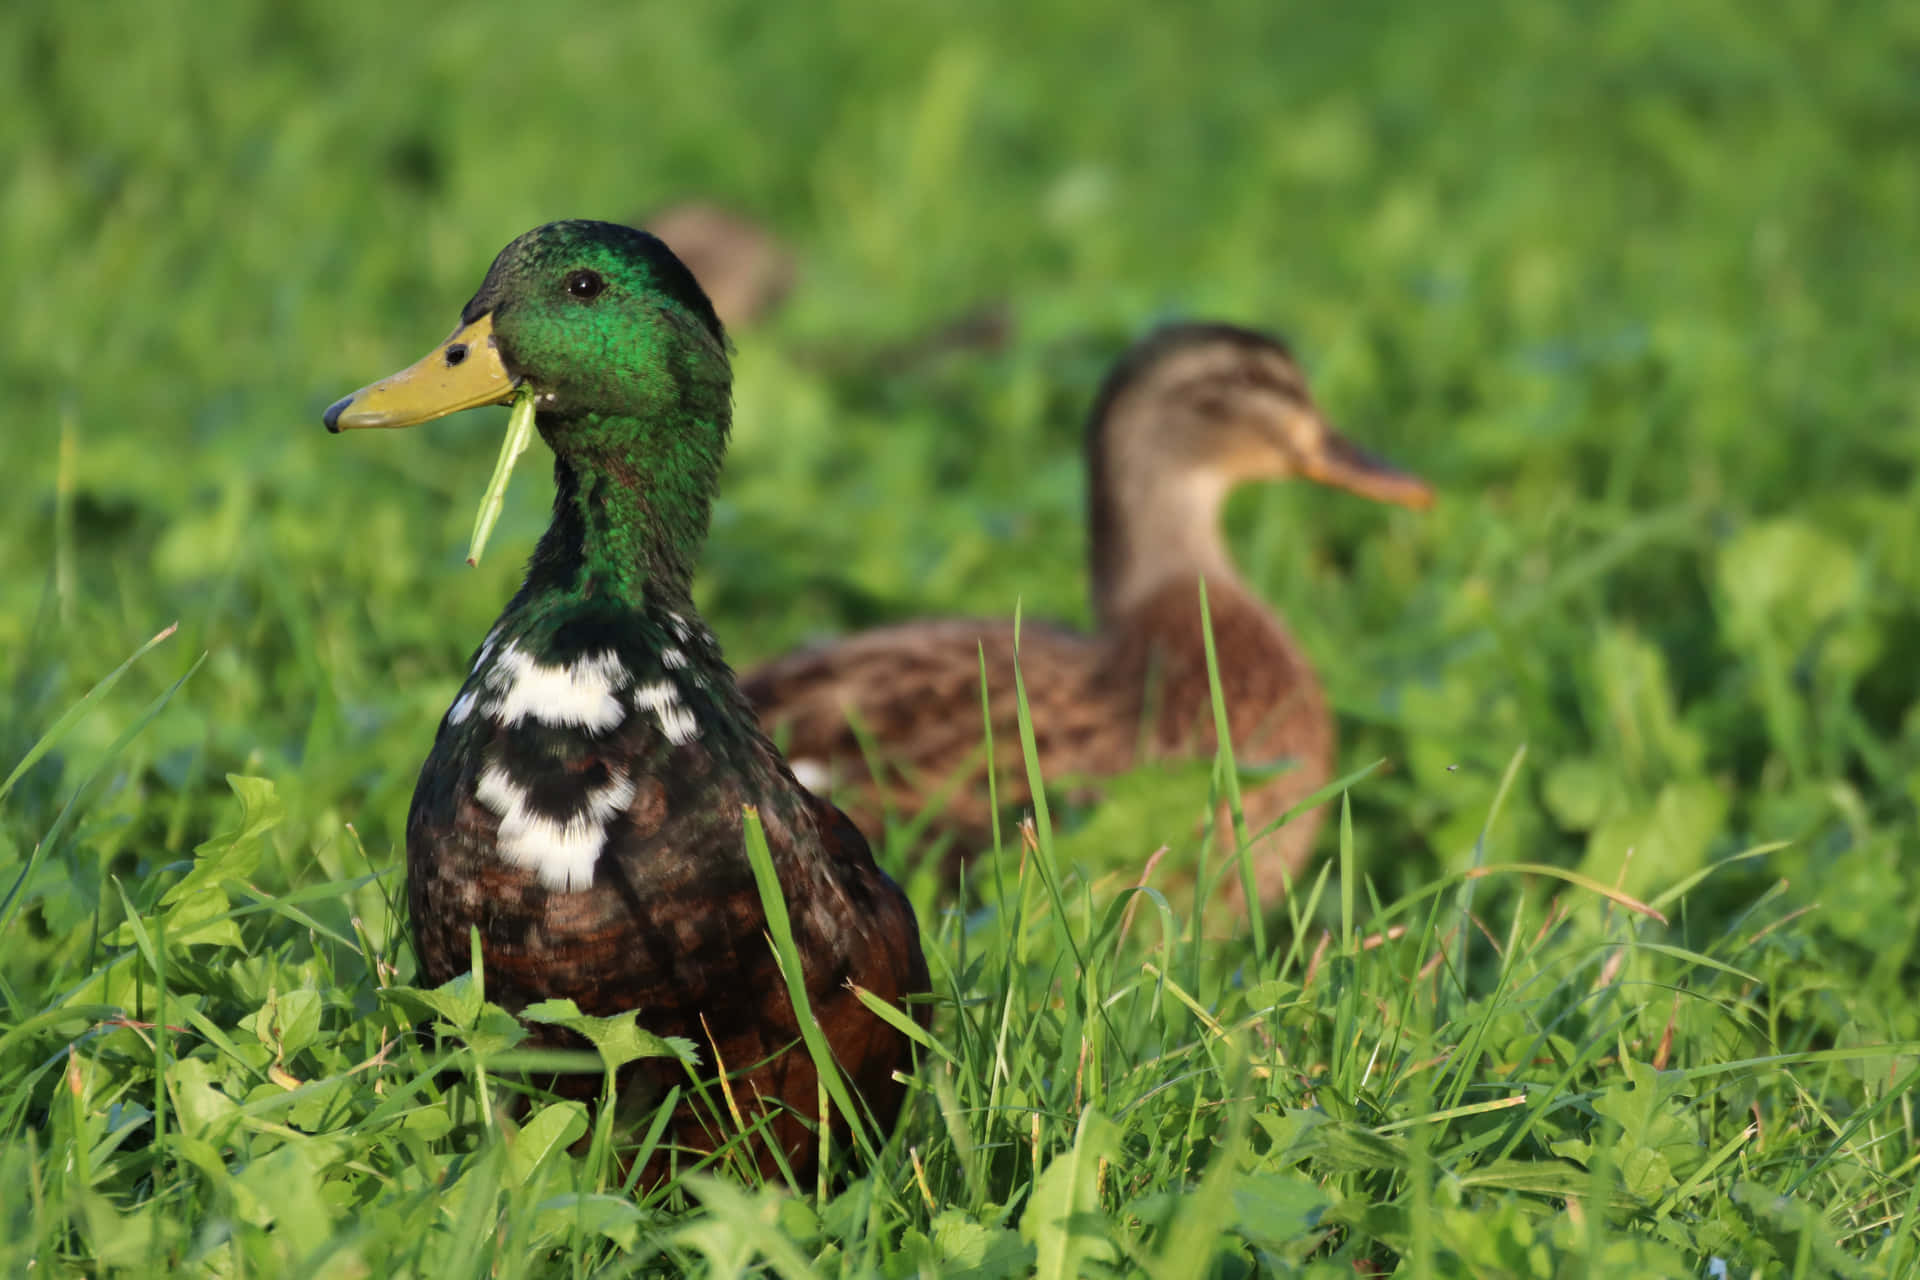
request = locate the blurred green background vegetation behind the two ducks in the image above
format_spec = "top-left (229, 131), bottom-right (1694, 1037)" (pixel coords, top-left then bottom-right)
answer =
top-left (0, 0), bottom-right (1920, 982)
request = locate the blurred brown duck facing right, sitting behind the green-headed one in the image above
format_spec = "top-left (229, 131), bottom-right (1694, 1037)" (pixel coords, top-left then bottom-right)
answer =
top-left (741, 322), bottom-right (1432, 910)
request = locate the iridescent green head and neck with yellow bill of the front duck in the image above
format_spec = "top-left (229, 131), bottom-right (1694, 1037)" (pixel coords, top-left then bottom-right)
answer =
top-left (324, 221), bottom-right (732, 599)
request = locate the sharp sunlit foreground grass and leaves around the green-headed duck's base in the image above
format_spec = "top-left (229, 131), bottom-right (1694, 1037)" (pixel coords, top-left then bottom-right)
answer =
top-left (0, 629), bottom-right (1920, 1276)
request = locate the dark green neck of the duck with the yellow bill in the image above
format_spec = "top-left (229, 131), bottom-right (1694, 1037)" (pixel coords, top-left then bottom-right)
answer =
top-left (515, 408), bottom-right (726, 610)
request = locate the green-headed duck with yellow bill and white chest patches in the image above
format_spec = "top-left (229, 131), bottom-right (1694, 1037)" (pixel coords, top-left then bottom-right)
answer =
top-left (324, 221), bottom-right (929, 1186)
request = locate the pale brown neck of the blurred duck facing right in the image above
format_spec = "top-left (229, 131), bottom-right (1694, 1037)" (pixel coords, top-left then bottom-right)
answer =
top-left (1089, 447), bottom-right (1240, 628)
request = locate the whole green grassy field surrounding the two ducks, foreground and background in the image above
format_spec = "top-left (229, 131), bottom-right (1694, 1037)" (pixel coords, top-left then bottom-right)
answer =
top-left (0, 0), bottom-right (1920, 1280)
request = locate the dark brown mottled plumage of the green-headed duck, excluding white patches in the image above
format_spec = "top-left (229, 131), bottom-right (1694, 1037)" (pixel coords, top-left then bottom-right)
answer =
top-left (407, 690), bottom-right (927, 1186)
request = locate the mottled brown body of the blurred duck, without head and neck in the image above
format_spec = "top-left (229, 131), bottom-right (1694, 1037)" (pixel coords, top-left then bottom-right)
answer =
top-left (747, 581), bottom-right (1334, 900)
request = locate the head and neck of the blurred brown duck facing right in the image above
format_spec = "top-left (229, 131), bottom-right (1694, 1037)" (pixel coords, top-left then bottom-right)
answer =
top-left (1087, 324), bottom-right (1432, 620)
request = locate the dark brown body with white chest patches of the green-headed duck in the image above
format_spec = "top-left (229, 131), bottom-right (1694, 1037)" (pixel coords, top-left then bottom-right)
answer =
top-left (407, 568), bottom-right (927, 1173)
